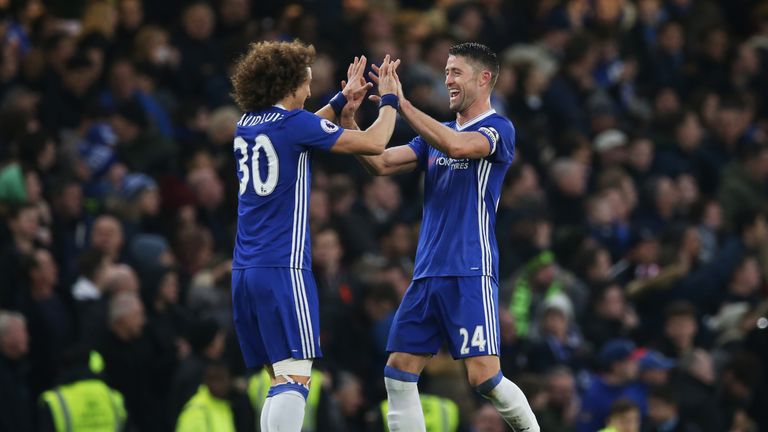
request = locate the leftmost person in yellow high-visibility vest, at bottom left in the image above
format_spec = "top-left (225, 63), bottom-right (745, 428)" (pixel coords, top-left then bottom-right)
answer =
top-left (38, 350), bottom-right (127, 432)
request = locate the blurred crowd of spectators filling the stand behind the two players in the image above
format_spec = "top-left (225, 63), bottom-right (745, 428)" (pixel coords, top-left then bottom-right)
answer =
top-left (0, 0), bottom-right (768, 432)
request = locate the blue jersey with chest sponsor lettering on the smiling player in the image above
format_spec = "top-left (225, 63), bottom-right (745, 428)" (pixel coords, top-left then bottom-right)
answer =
top-left (408, 110), bottom-right (515, 280)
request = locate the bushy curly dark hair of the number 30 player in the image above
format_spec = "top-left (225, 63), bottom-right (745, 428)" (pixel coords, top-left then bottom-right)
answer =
top-left (232, 41), bottom-right (315, 111)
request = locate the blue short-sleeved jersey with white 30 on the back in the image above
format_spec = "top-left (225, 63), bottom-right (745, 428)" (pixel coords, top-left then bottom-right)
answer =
top-left (232, 106), bottom-right (343, 270)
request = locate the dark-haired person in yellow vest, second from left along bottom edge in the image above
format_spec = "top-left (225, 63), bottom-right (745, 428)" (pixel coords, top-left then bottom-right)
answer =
top-left (176, 364), bottom-right (236, 432)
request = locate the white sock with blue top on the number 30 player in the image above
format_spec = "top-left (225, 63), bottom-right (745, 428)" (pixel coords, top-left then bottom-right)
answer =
top-left (262, 383), bottom-right (307, 432)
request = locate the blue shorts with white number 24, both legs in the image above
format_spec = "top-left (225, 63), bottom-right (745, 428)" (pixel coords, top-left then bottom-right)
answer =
top-left (387, 276), bottom-right (499, 359)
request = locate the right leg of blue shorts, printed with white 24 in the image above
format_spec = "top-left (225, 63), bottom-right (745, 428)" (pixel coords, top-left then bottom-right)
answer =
top-left (436, 276), bottom-right (499, 359)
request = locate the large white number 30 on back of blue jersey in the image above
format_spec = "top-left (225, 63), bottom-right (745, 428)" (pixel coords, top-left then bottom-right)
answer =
top-left (235, 134), bottom-right (280, 196)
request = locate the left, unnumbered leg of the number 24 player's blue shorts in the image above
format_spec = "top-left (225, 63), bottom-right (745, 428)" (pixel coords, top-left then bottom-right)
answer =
top-left (387, 279), bottom-right (441, 354)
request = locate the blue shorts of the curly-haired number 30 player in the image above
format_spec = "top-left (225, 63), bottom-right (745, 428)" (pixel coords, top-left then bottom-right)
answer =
top-left (232, 267), bottom-right (322, 368)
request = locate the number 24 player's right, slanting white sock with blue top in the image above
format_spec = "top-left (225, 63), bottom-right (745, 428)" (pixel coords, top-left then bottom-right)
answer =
top-left (476, 371), bottom-right (541, 432)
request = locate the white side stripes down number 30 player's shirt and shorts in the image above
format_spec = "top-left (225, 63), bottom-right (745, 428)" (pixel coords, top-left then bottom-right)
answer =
top-left (291, 151), bottom-right (315, 358)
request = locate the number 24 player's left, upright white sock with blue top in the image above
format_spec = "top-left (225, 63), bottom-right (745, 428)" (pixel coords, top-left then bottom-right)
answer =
top-left (384, 366), bottom-right (426, 432)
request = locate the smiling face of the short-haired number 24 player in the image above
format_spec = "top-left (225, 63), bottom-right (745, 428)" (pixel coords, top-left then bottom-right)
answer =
top-left (445, 55), bottom-right (491, 113)
